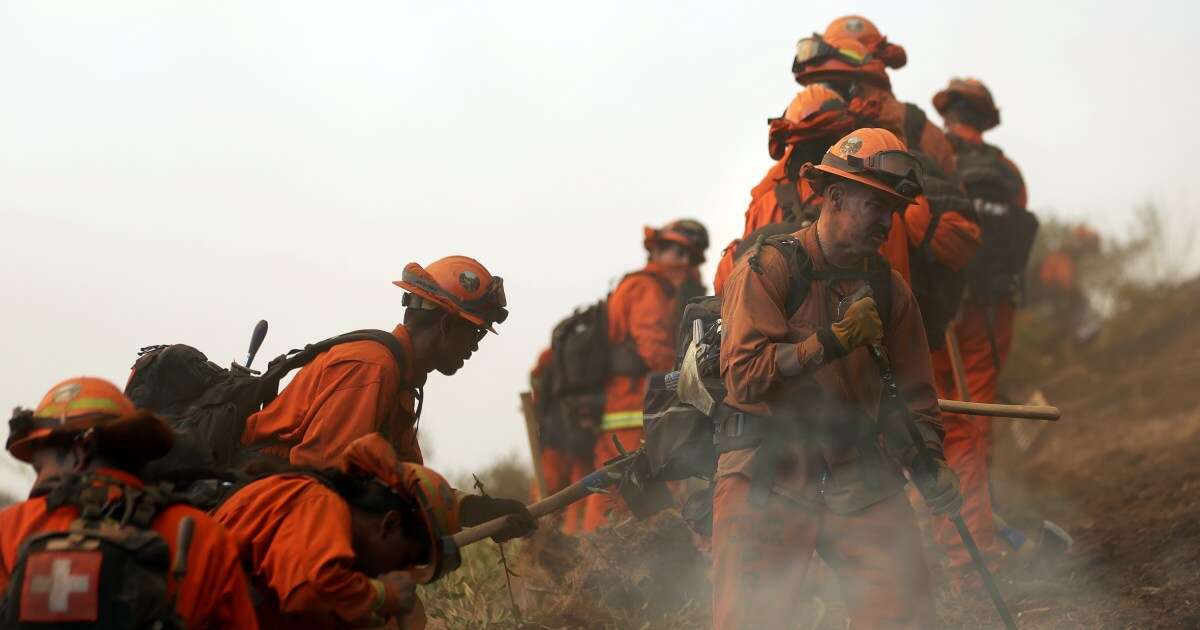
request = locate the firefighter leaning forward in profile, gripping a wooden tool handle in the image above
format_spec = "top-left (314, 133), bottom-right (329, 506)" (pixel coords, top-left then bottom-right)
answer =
top-left (241, 256), bottom-right (535, 540)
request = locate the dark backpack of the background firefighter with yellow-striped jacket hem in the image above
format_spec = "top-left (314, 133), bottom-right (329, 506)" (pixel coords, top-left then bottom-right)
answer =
top-left (546, 271), bottom-right (682, 444)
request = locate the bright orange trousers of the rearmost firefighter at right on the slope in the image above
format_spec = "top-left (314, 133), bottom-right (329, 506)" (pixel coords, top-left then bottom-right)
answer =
top-left (932, 302), bottom-right (1014, 570)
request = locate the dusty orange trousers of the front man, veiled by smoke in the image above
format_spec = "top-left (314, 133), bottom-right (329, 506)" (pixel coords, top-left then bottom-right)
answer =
top-left (713, 475), bottom-right (935, 630)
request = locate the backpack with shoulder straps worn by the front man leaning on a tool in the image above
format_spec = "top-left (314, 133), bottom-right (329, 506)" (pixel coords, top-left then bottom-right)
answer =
top-left (643, 230), bottom-right (892, 481)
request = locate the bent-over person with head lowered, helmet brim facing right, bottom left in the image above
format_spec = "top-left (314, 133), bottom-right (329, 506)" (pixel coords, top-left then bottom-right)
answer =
top-left (215, 433), bottom-right (458, 630)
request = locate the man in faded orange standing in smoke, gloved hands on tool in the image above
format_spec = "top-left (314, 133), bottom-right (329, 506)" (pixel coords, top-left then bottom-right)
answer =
top-left (713, 128), bottom-right (962, 629)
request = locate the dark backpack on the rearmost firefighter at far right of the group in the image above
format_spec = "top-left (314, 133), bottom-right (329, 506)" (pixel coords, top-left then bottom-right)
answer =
top-left (949, 136), bottom-right (1038, 304)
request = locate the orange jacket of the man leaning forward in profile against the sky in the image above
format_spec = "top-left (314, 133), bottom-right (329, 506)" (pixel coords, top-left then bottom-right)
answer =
top-left (241, 324), bottom-right (425, 468)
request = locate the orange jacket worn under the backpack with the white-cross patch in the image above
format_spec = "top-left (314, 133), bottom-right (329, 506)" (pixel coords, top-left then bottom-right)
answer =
top-left (0, 468), bottom-right (258, 629)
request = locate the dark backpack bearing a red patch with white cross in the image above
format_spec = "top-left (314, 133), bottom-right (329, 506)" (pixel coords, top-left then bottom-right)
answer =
top-left (0, 474), bottom-right (184, 630)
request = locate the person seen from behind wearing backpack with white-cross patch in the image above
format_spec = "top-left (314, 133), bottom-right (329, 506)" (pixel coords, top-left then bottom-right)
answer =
top-left (0, 378), bottom-right (257, 629)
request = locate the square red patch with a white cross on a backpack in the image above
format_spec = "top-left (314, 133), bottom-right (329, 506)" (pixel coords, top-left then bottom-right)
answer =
top-left (20, 551), bottom-right (103, 622)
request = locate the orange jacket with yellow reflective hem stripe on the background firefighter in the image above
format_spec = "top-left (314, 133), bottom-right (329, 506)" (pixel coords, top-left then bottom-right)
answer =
top-left (601, 263), bottom-right (698, 431)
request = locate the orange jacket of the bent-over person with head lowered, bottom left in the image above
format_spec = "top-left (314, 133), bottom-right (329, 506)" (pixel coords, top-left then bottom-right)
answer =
top-left (214, 474), bottom-right (386, 630)
